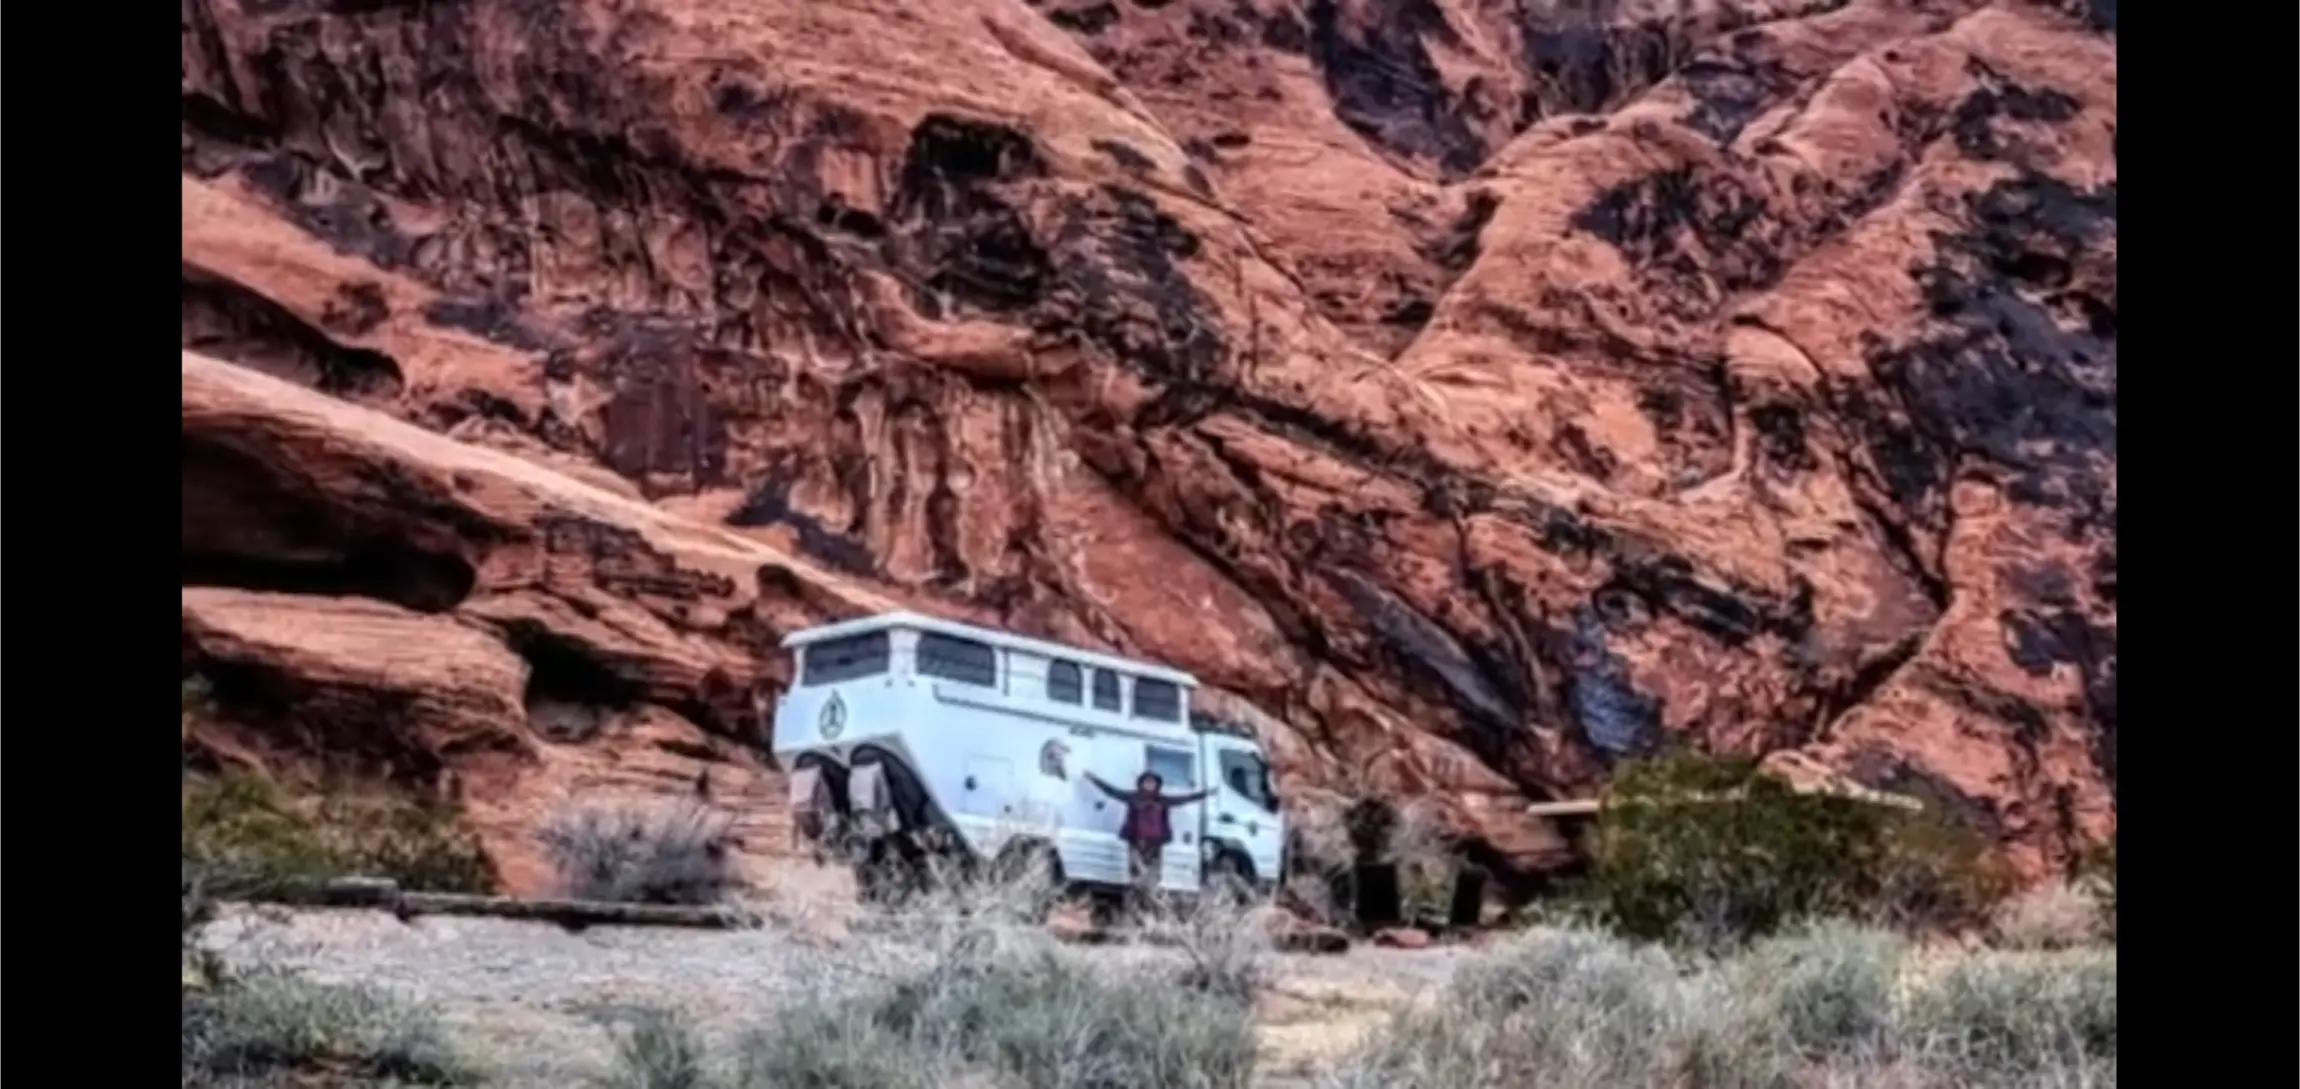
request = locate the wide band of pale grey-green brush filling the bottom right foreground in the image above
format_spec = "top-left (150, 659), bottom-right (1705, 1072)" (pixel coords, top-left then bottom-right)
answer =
top-left (1320, 923), bottom-right (2116, 1089)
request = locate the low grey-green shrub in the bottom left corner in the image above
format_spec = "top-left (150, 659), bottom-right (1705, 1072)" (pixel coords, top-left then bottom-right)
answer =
top-left (184, 969), bottom-right (476, 1087)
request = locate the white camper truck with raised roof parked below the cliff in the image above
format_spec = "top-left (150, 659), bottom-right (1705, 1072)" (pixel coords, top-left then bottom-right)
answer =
top-left (775, 612), bottom-right (1286, 896)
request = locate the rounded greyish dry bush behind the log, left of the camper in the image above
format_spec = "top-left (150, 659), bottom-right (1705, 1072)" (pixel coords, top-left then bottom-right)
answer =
top-left (541, 801), bottom-right (741, 905)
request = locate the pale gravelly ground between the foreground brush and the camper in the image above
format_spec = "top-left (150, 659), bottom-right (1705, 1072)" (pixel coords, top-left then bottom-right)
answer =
top-left (188, 870), bottom-right (1465, 1089)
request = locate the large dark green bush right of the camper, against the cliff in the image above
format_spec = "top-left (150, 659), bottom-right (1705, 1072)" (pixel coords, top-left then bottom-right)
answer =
top-left (1587, 753), bottom-right (2003, 946)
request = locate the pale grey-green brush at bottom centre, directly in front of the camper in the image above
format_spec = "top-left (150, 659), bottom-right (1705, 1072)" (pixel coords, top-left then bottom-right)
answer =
top-left (610, 851), bottom-right (1258, 1089)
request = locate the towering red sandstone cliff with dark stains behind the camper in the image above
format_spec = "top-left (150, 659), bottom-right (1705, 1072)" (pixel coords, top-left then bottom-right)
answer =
top-left (182, 0), bottom-right (2116, 882)
